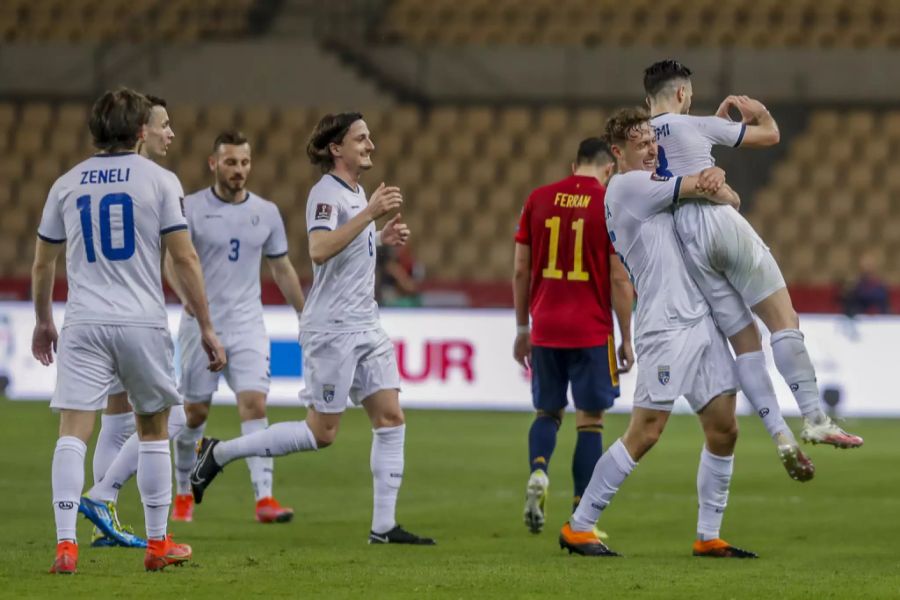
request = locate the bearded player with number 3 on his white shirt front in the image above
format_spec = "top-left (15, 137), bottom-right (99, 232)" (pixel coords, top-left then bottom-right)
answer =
top-left (167, 131), bottom-right (303, 523)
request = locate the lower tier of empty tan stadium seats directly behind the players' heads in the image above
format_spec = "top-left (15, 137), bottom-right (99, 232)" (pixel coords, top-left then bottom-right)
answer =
top-left (0, 102), bottom-right (900, 310)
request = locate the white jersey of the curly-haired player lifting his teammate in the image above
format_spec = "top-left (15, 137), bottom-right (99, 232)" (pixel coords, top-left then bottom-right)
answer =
top-left (606, 171), bottom-right (709, 342)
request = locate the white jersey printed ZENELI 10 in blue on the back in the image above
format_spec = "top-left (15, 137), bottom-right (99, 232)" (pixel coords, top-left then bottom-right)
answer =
top-left (38, 152), bottom-right (187, 327)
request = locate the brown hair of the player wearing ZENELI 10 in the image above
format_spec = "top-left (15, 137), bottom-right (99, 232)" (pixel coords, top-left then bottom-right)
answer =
top-left (88, 87), bottom-right (151, 152)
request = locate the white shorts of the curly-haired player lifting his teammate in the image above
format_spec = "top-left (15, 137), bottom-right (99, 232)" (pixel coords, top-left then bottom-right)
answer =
top-left (634, 316), bottom-right (738, 412)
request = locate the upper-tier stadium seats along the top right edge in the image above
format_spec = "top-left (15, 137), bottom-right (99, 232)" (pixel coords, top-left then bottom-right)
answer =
top-left (381, 0), bottom-right (900, 48)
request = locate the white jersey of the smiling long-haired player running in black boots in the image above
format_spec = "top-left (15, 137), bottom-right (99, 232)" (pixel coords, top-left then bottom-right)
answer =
top-left (300, 173), bottom-right (378, 333)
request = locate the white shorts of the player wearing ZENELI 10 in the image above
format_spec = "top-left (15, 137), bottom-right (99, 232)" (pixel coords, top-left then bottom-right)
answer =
top-left (50, 324), bottom-right (181, 415)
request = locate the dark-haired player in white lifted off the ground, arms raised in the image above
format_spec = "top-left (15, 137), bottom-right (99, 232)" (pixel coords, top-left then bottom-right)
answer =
top-left (644, 60), bottom-right (863, 468)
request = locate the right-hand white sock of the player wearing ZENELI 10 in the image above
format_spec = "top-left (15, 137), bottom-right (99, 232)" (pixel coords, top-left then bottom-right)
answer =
top-left (137, 440), bottom-right (172, 540)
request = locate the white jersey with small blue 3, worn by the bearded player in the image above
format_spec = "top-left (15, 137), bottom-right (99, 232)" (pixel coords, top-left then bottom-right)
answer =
top-left (184, 187), bottom-right (288, 332)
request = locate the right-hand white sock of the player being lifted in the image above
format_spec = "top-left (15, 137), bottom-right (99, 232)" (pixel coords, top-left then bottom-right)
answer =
top-left (771, 329), bottom-right (825, 423)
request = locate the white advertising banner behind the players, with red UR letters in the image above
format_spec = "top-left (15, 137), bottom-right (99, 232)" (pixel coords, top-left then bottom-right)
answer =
top-left (0, 303), bottom-right (900, 416)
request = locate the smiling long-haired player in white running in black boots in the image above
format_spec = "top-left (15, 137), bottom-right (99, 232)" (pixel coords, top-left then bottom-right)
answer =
top-left (191, 113), bottom-right (434, 545)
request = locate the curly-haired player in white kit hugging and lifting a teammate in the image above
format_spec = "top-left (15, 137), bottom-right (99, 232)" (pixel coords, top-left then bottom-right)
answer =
top-left (559, 108), bottom-right (756, 558)
